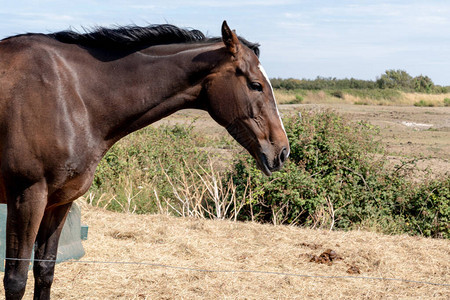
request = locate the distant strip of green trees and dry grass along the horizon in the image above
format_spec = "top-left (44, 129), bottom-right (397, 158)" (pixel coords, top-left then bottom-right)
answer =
top-left (271, 70), bottom-right (450, 106)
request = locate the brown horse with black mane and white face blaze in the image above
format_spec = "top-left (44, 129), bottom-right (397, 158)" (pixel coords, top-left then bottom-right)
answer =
top-left (0, 22), bottom-right (289, 299)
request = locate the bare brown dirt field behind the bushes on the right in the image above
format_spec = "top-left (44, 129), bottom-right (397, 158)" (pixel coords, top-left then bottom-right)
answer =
top-left (296, 104), bottom-right (450, 160)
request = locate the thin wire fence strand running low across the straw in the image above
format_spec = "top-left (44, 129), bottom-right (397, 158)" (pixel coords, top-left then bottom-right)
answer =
top-left (4, 258), bottom-right (450, 287)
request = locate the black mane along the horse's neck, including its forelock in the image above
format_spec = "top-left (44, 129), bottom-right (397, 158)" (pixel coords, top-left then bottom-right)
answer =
top-left (47, 24), bottom-right (259, 56)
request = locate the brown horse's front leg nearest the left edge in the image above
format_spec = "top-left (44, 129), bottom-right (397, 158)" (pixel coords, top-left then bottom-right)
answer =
top-left (3, 180), bottom-right (47, 300)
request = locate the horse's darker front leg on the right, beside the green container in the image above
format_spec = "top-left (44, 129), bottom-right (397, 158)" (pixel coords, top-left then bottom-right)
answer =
top-left (33, 203), bottom-right (72, 299)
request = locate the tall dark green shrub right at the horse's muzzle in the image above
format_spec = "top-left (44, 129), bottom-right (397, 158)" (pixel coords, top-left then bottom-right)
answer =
top-left (234, 112), bottom-right (379, 227)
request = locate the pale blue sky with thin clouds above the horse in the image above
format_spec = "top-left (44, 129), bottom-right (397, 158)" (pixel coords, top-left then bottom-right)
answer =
top-left (0, 0), bottom-right (450, 85)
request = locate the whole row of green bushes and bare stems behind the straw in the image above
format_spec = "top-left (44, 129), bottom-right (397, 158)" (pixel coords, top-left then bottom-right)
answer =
top-left (86, 111), bottom-right (450, 238)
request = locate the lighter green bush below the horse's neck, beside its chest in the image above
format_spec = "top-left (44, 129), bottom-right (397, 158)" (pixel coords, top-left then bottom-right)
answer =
top-left (90, 125), bottom-right (213, 213)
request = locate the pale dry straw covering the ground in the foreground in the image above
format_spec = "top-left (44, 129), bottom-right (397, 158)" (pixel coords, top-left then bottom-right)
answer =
top-left (10, 204), bottom-right (450, 299)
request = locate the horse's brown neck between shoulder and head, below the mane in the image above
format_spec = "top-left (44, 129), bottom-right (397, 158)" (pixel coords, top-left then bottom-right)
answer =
top-left (94, 44), bottom-right (221, 146)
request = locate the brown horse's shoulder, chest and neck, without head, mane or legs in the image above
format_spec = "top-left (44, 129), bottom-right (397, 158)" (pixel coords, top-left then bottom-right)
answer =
top-left (0, 36), bottom-right (217, 205)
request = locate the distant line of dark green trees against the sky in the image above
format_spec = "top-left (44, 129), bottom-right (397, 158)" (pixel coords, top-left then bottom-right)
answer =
top-left (270, 70), bottom-right (450, 93)
